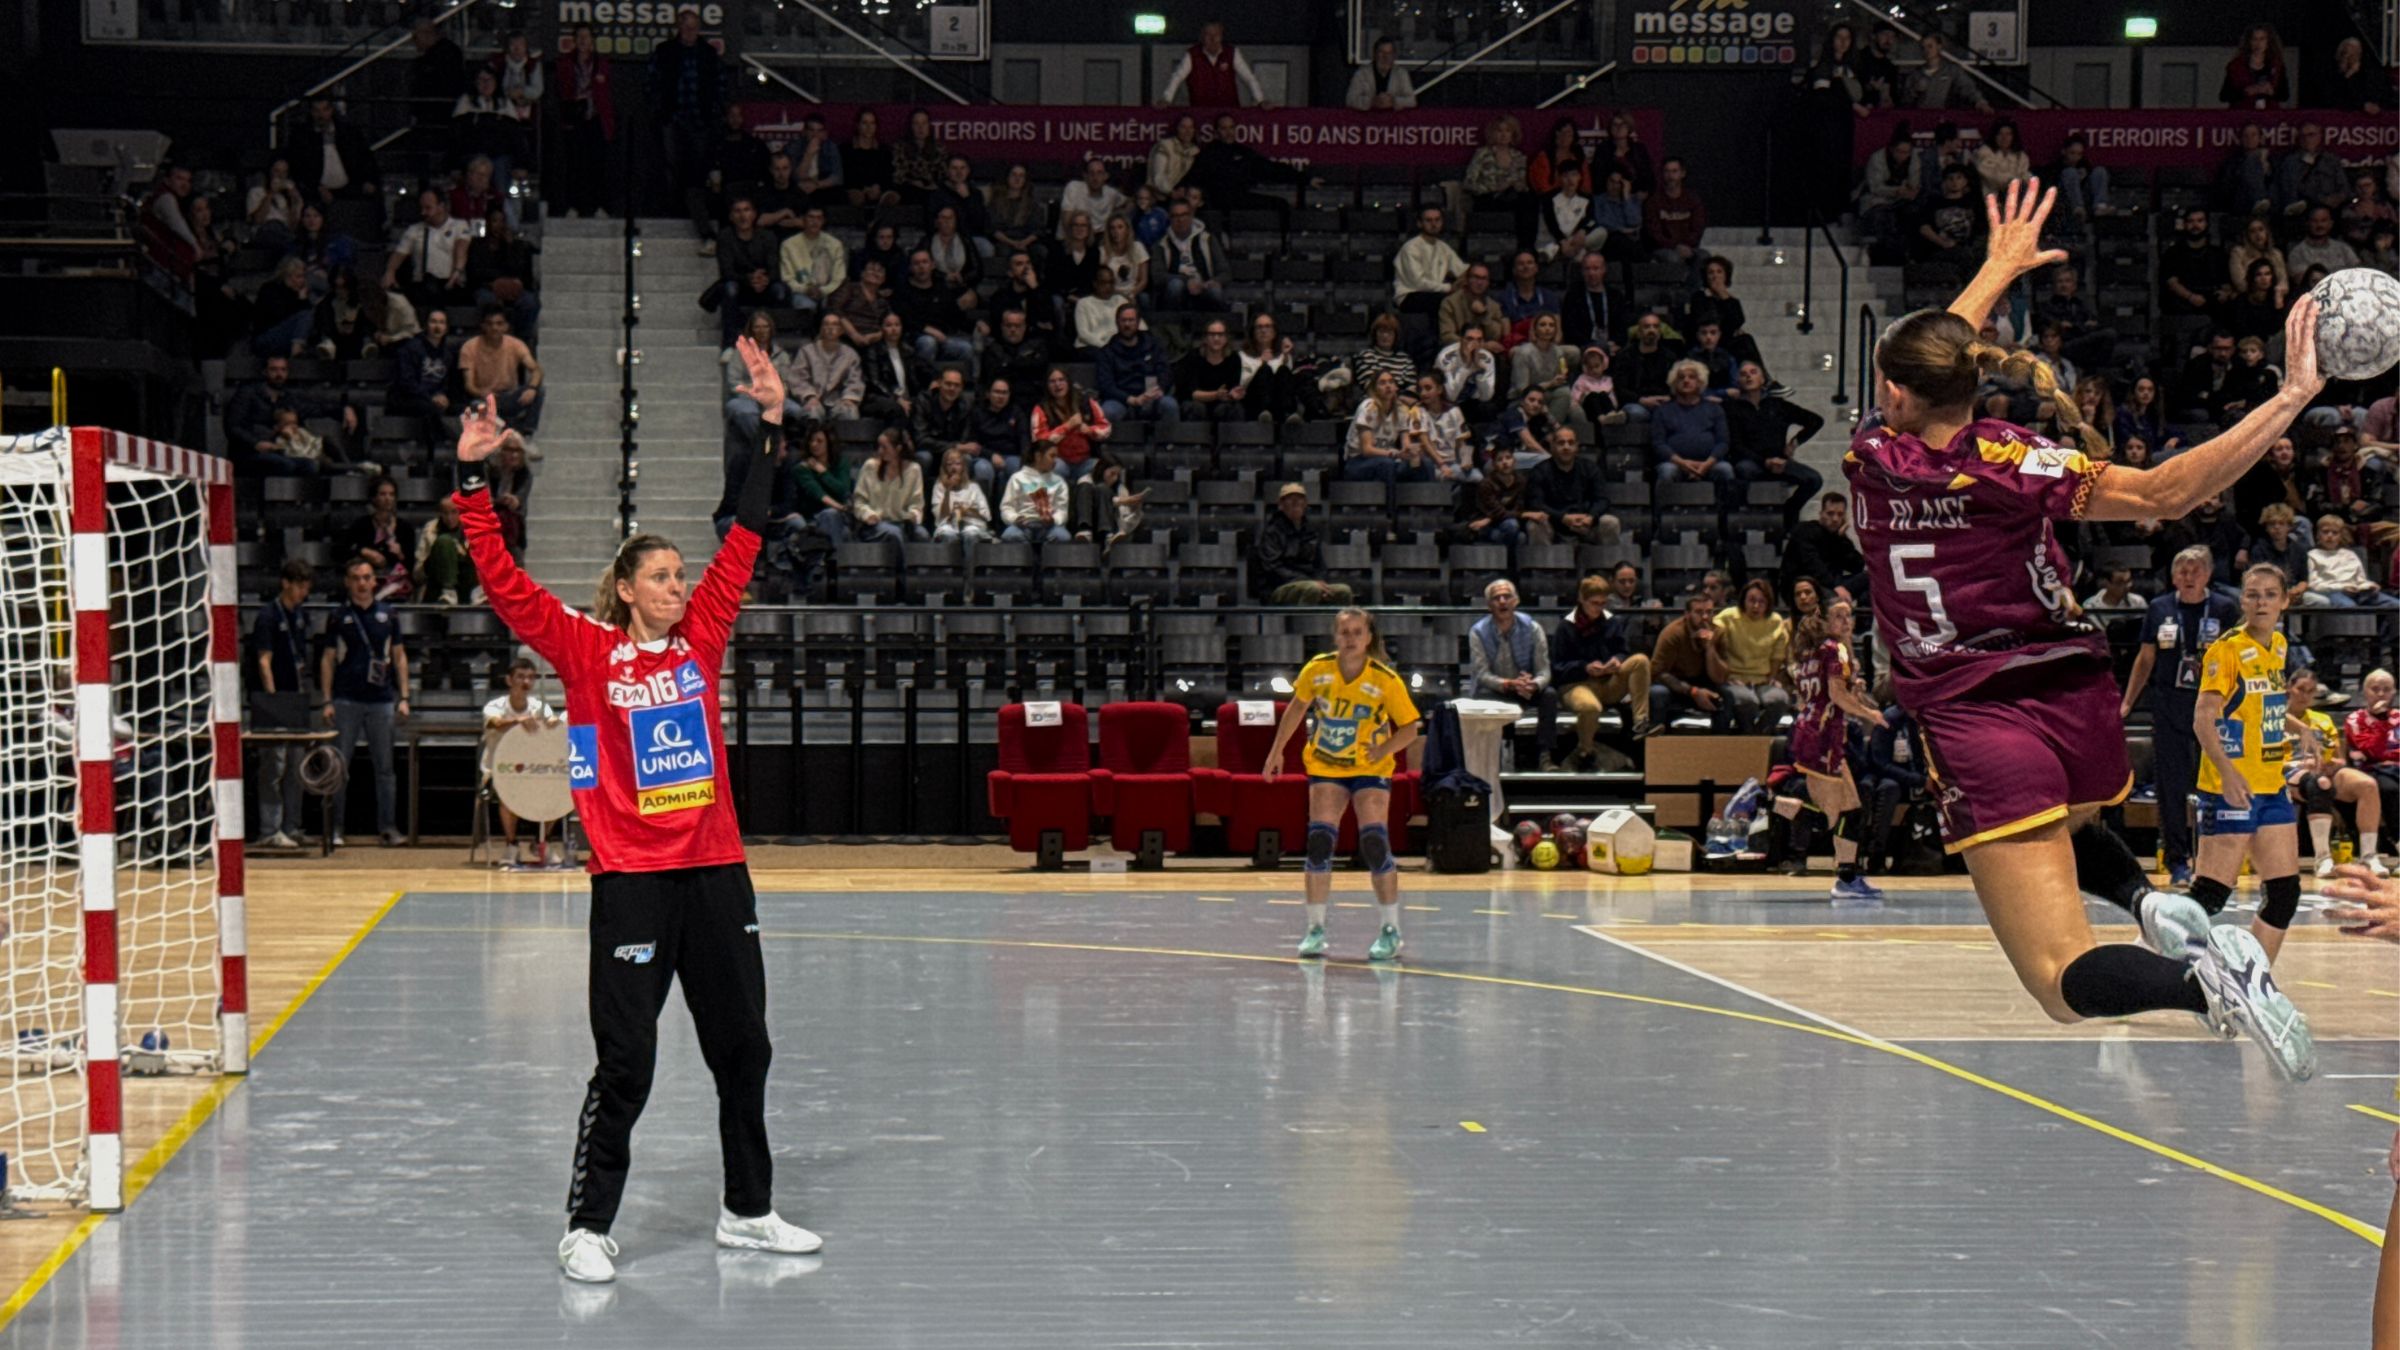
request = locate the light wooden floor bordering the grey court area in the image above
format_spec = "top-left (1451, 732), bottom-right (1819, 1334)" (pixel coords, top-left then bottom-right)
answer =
top-left (0, 846), bottom-right (2400, 1326)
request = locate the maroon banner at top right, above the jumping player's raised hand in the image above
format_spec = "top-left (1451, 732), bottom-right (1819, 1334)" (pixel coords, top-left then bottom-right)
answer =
top-left (1850, 108), bottom-right (2400, 168)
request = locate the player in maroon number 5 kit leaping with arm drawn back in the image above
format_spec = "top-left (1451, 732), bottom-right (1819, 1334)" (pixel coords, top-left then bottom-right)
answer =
top-left (1843, 180), bottom-right (2323, 1079)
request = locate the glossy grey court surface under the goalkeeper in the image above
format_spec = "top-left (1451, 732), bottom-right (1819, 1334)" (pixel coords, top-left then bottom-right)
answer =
top-left (0, 877), bottom-right (2393, 1350)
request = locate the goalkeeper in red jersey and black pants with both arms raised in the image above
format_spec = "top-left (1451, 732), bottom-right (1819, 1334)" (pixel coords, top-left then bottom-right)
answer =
top-left (456, 339), bottom-right (823, 1280)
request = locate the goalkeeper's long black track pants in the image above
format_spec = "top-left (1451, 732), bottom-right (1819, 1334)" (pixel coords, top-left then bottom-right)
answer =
top-left (566, 862), bottom-right (775, 1232)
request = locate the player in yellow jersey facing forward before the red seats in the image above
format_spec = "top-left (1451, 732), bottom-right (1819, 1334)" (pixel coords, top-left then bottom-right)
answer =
top-left (1262, 610), bottom-right (1421, 961)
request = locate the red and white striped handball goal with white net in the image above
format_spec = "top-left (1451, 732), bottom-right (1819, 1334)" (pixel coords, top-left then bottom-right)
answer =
top-left (0, 428), bottom-right (250, 1211)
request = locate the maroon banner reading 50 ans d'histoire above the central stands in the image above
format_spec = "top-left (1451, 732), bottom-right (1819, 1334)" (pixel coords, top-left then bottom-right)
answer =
top-left (749, 103), bottom-right (1663, 178)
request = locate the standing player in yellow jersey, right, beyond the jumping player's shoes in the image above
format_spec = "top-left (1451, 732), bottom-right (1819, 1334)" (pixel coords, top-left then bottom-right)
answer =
top-left (2191, 562), bottom-right (2299, 961)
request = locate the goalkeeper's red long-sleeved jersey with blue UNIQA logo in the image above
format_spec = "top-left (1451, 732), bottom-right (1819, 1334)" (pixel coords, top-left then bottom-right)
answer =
top-left (454, 488), bottom-right (758, 872)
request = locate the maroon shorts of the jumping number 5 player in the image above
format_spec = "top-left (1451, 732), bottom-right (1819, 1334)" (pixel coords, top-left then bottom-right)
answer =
top-left (1910, 653), bottom-right (2134, 853)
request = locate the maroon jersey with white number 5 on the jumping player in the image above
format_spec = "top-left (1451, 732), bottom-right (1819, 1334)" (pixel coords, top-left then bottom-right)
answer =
top-left (1843, 420), bottom-right (2107, 696)
